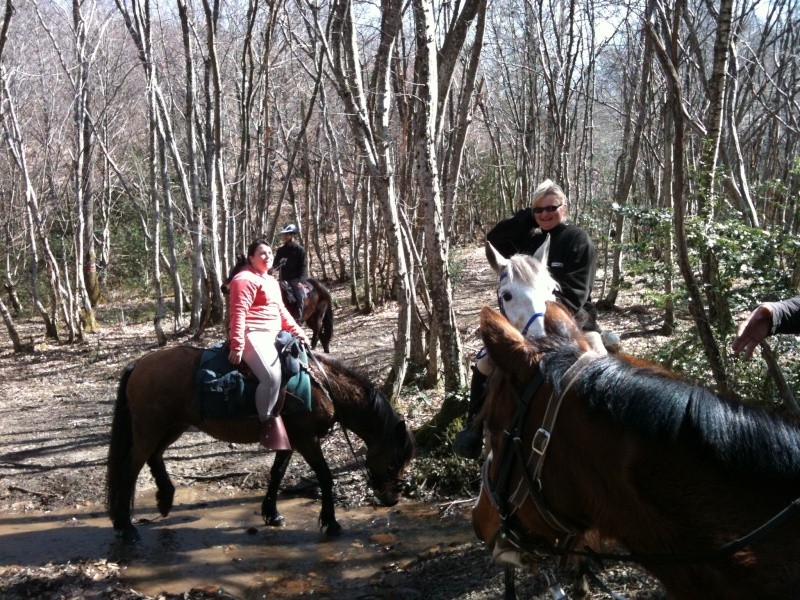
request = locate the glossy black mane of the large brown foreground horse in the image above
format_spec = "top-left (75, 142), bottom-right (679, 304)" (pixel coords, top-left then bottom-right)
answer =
top-left (541, 346), bottom-right (800, 479)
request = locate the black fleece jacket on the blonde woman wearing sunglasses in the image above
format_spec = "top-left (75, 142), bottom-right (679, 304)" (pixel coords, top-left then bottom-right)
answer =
top-left (486, 208), bottom-right (599, 331)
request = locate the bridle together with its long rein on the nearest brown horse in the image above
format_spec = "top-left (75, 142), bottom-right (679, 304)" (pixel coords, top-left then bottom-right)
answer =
top-left (481, 351), bottom-right (800, 565)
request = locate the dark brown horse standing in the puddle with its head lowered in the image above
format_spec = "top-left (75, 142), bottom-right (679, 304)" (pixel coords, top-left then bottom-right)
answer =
top-left (106, 346), bottom-right (414, 540)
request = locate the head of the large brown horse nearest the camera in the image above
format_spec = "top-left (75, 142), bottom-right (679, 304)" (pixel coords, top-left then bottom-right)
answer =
top-left (472, 302), bottom-right (590, 564)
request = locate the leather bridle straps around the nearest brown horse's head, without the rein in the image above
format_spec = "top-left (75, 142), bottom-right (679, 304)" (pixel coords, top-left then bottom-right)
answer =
top-left (481, 352), bottom-right (598, 554)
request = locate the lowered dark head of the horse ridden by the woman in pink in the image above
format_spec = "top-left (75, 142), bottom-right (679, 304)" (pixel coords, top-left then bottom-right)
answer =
top-left (364, 412), bottom-right (416, 506)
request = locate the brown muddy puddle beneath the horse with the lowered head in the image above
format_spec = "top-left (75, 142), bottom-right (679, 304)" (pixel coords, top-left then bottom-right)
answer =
top-left (0, 489), bottom-right (475, 599)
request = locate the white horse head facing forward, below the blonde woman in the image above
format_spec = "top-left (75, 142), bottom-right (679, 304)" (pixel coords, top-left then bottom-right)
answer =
top-left (486, 236), bottom-right (558, 337)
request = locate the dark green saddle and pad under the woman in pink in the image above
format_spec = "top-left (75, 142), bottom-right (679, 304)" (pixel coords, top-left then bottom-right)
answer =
top-left (194, 340), bottom-right (312, 419)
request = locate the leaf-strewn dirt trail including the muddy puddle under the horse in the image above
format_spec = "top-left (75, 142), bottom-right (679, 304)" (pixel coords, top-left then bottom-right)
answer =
top-left (0, 247), bottom-right (655, 600)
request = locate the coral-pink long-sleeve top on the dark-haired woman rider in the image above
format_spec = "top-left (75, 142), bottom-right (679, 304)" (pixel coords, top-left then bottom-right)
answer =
top-left (228, 265), bottom-right (305, 356)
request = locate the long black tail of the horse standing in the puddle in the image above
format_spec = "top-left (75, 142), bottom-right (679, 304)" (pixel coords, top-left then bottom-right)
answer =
top-left (106, 365), bottom-right (134, 525)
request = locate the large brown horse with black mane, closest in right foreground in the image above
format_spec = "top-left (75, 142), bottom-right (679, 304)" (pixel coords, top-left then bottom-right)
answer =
top-left (472, 304), bottom-right (800, 600)
